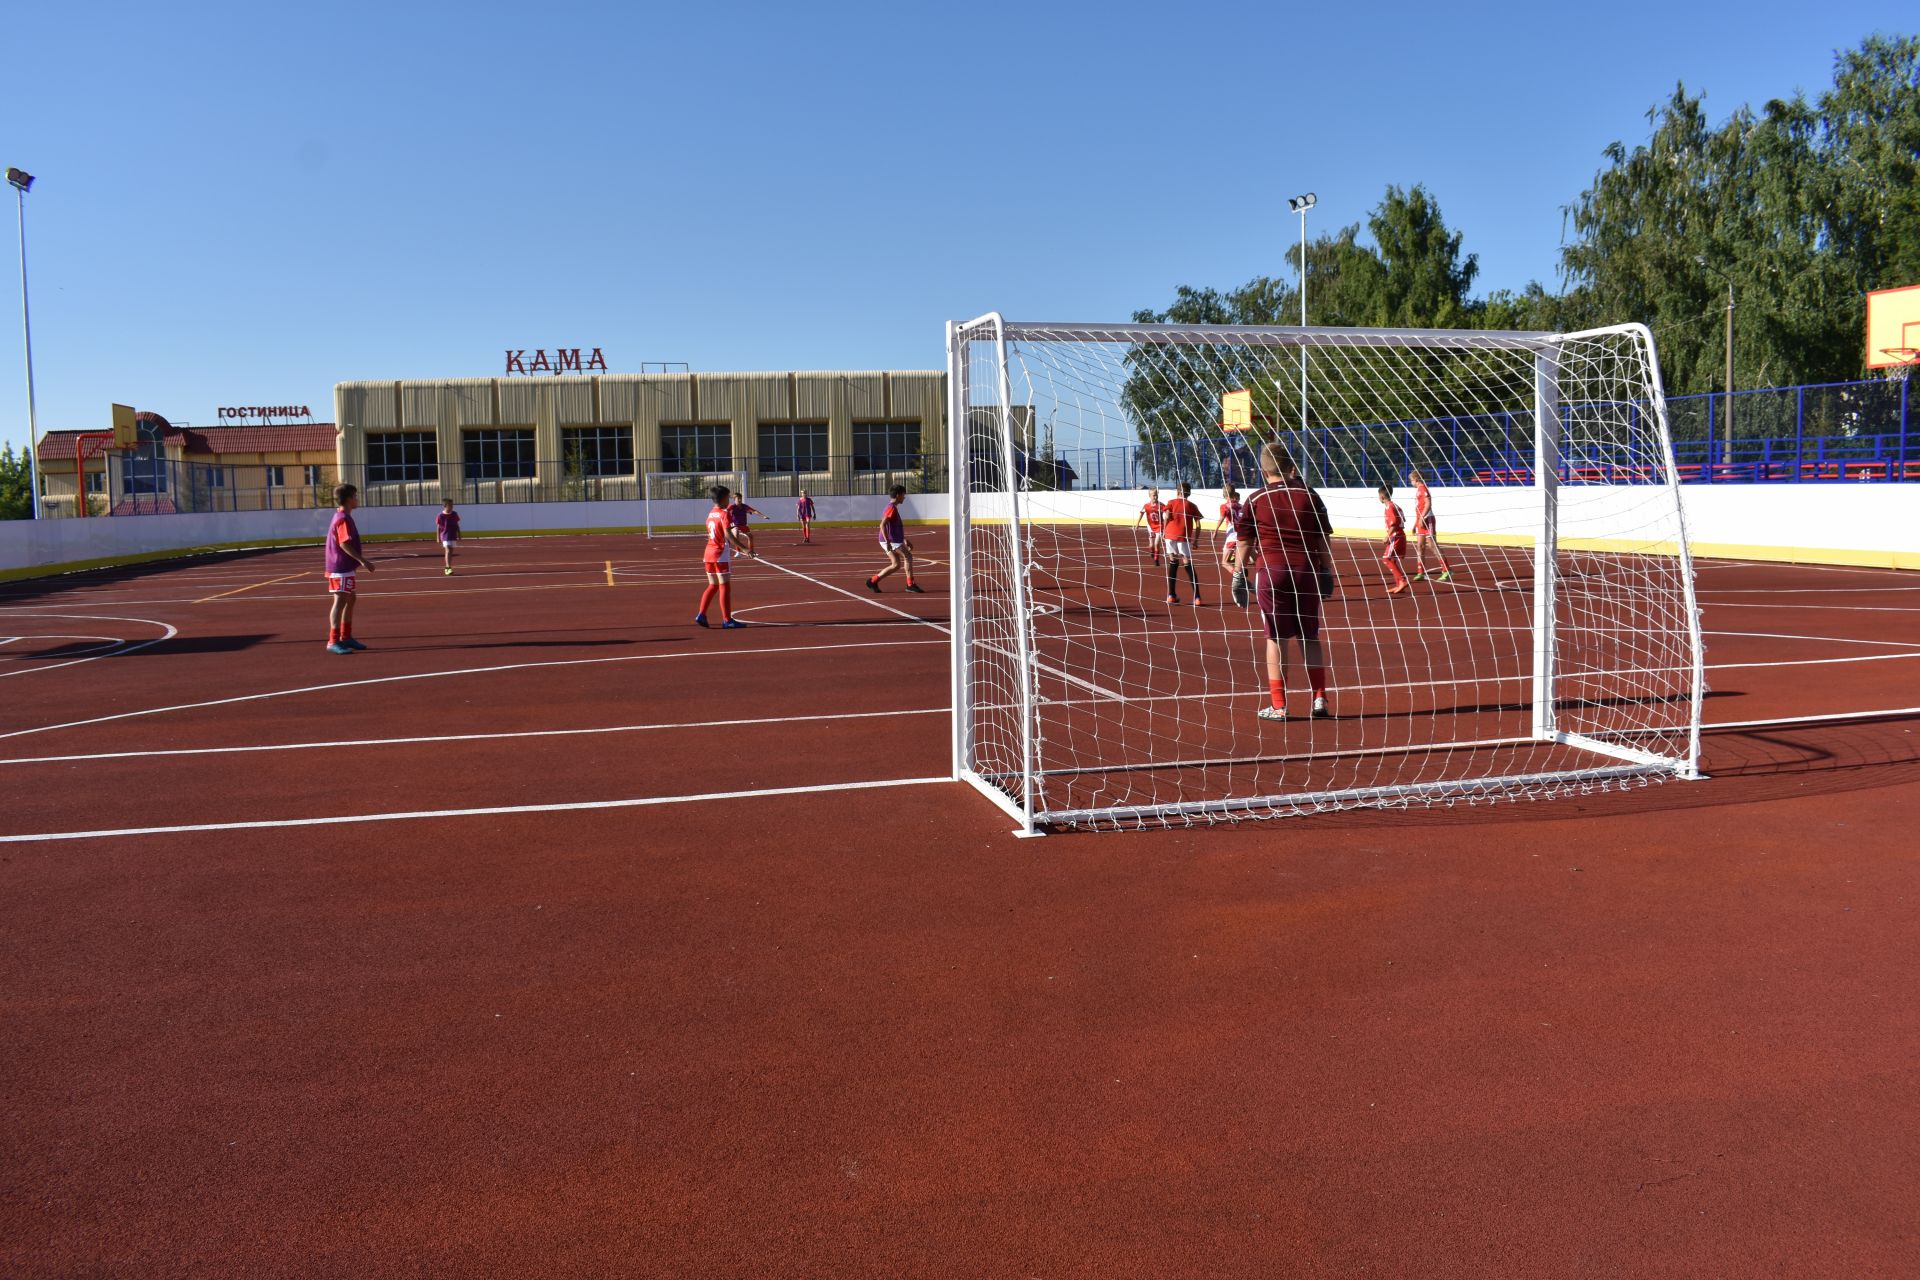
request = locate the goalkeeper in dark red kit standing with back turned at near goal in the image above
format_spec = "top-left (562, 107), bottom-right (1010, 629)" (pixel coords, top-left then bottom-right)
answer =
top-left (1238, 443), bottom-right (1334, 720)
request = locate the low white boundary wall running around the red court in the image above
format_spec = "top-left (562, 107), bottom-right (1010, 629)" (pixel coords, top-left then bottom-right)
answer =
top-left (0, 484), bottom-right (1920, 572)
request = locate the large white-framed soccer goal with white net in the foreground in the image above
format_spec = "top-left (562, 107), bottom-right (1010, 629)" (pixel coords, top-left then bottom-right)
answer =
top-left (948, 315), bottom-right (1705, 833)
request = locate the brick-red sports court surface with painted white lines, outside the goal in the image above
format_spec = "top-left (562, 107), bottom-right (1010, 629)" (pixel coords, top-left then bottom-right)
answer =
top-left (0, 528), bottom-right (1920, 1276)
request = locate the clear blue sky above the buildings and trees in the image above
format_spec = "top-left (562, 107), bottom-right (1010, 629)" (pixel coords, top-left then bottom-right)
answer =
top-left (0, 0), bottom-right (1897, 445)
